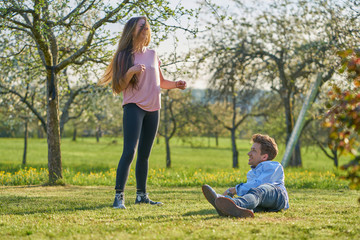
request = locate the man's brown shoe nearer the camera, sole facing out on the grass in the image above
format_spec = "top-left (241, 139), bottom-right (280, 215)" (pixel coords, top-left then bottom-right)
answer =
top-left (215, 197), bottom-right (254, 218)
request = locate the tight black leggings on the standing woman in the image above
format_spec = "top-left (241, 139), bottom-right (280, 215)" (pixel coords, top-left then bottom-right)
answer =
top-left (115, 103), bottom-right (160, 192)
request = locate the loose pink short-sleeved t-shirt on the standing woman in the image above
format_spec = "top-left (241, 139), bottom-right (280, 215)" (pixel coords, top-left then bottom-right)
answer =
top-left (123, 48), bottom-right (161, 112)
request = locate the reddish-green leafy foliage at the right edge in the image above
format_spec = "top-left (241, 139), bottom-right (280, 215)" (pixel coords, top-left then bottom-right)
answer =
top-left (324, 49), bottom-right (360, 189)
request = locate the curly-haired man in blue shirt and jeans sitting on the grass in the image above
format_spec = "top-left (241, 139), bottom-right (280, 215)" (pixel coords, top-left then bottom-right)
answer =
top-left (202, 134), bottom-right (289, 217)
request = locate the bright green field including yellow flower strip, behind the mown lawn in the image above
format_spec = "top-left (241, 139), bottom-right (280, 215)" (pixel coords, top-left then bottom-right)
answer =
top-left (0, 138), bottom-right (348, 189)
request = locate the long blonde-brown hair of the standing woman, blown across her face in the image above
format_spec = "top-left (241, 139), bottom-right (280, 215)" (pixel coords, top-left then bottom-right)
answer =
top-left (98, 16), bottom-right (151, 94)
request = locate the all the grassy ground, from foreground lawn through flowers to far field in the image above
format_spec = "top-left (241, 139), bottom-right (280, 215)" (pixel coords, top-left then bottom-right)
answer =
top-left (0, 138), bottom-right (360, 239)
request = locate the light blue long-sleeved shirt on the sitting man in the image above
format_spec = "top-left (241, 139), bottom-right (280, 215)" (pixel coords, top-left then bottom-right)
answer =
top-left (235, 161), bottom-right (289, 209)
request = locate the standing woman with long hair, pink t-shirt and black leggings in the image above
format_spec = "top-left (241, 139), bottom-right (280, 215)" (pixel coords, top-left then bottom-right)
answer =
top-left (99, 17), bottom-right (186, 208)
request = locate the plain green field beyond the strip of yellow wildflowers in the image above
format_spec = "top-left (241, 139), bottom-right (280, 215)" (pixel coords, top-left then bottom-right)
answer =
top-left (0, 138), bottom-right (348, 172)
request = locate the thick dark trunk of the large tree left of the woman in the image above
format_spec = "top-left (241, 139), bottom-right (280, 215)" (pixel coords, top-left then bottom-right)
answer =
top-left (46, 73), bottom-right (62, 185)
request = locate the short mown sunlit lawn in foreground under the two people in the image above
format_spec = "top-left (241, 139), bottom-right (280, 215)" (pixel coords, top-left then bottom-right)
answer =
top-left (0, 186), bottom-right (360, 239)
